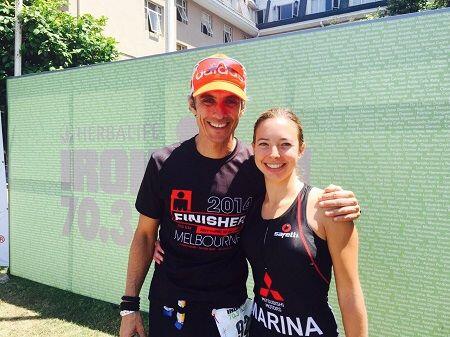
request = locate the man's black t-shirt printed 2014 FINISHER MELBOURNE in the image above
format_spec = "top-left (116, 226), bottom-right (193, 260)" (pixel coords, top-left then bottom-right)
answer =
top-left (136, 138), bottom-right (264, 307)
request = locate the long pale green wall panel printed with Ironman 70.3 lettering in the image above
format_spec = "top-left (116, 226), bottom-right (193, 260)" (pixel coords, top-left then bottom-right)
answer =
top-left (7, 9), bottom-right (450, 337)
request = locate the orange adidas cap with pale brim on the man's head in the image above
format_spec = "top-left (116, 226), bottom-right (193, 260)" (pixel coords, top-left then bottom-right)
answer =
top-left (191, 54), bottom-right (247, 101)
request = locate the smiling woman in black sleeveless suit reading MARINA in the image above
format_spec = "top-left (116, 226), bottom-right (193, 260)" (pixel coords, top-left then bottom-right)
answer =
top-left (241, 109), bottom-right (368, 337)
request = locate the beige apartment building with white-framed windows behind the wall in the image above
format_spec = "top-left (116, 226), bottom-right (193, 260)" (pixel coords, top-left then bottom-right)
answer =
top-left (68, 0), bottom-right (258, 59)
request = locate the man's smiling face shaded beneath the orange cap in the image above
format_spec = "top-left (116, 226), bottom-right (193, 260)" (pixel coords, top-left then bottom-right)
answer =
top-left (191, 90), bottom-right (242, 145)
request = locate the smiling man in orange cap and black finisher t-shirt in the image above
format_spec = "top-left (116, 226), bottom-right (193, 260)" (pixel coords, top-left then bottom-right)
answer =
top-left (120, 54), bottom-right (359, 337)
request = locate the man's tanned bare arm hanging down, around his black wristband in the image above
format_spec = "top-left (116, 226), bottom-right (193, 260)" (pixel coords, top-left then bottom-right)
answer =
top-left (120, 214), bottom-right (159, 337)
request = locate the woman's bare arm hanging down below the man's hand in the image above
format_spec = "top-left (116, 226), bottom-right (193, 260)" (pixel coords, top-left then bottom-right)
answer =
top-left (320, 216), bottom-right (368, 337)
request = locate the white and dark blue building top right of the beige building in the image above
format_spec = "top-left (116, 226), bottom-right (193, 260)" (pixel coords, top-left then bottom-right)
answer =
top-left (255, 0), bottom-right (387, 36)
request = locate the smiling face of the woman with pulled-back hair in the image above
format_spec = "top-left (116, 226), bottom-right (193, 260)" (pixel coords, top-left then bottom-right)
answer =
top-left (253, 117), bottom-right (303, 182)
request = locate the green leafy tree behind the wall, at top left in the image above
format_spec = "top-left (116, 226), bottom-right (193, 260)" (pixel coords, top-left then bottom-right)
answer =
top-left (0, 0), bottom-right (118, 150)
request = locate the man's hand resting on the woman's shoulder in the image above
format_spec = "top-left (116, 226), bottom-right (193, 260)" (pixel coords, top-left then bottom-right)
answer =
top-left (319, 185), bottom-right (361, 221)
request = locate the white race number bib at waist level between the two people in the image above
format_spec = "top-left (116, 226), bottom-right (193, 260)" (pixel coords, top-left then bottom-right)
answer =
top-left (212, 298), bottom-right (253, 337)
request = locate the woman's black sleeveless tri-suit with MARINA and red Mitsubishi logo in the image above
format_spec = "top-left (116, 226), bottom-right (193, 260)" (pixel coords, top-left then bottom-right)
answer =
top-left (241, 185), bottom-right (339, 337)
